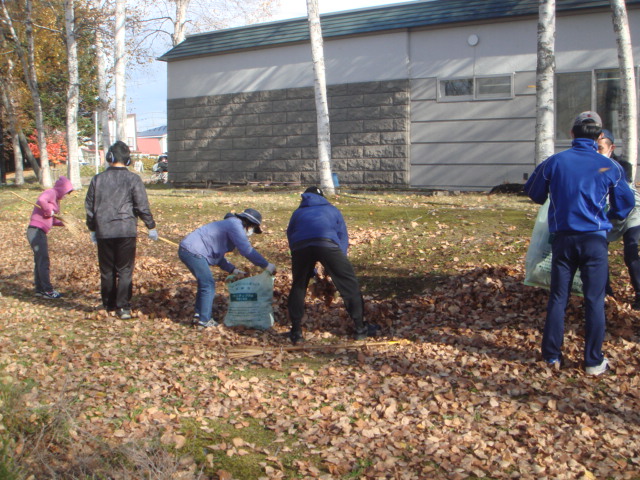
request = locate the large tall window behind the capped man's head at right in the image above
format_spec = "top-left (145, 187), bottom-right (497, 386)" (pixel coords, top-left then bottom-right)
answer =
top-left (555, 68), bottom-right (637, 143)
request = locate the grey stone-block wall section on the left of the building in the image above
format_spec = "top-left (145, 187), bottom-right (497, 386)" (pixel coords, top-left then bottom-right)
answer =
top-left (168, 80), bottom-right (410, 186)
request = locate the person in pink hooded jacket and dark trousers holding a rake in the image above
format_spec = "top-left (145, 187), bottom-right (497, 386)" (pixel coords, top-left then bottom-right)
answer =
top-left (27, 176), bottom-right (73, 298)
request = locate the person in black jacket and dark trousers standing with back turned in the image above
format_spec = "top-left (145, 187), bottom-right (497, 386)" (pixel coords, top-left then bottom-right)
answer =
top-left (84, 141), bottom-right (158, 319)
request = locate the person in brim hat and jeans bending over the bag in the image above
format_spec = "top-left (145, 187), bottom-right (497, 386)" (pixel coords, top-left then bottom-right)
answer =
top-left (178, 208), bottom-right (276, 328)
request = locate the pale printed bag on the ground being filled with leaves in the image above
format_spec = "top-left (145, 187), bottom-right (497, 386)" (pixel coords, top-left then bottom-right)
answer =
top-left (224, 270), bottom-right (273, 330)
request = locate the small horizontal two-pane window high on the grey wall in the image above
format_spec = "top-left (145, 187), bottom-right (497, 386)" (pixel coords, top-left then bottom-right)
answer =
top-left (438, 75), bottom-right (513, 102)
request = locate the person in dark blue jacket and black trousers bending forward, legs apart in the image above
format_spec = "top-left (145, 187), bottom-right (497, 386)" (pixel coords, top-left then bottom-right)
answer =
top-left (287, 187), bottom-right (380, 345)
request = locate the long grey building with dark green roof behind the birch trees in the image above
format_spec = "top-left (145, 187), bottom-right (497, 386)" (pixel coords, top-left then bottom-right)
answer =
top-left (161, 0), bottom-right (640, 190)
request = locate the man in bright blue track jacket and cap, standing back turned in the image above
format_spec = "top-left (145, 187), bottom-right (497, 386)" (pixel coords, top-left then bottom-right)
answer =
top-left (524, 112), bottom-right (635, 375)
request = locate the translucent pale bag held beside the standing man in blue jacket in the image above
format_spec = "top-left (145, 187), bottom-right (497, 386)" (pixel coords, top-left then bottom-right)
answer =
top-left (524, 199), bottom-right (582, 295)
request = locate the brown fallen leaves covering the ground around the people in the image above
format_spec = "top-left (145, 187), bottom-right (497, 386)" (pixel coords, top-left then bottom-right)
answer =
top-left (0, 189), bottom-right (640, 479)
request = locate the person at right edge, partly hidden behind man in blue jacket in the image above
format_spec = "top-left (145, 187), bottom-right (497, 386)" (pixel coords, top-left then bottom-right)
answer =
top-left (598, 129), bottom-right (640, 310)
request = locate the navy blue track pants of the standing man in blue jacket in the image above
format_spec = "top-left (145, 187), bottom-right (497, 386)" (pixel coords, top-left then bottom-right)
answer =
top-left (542, 233), bottom-right (608, 367)
